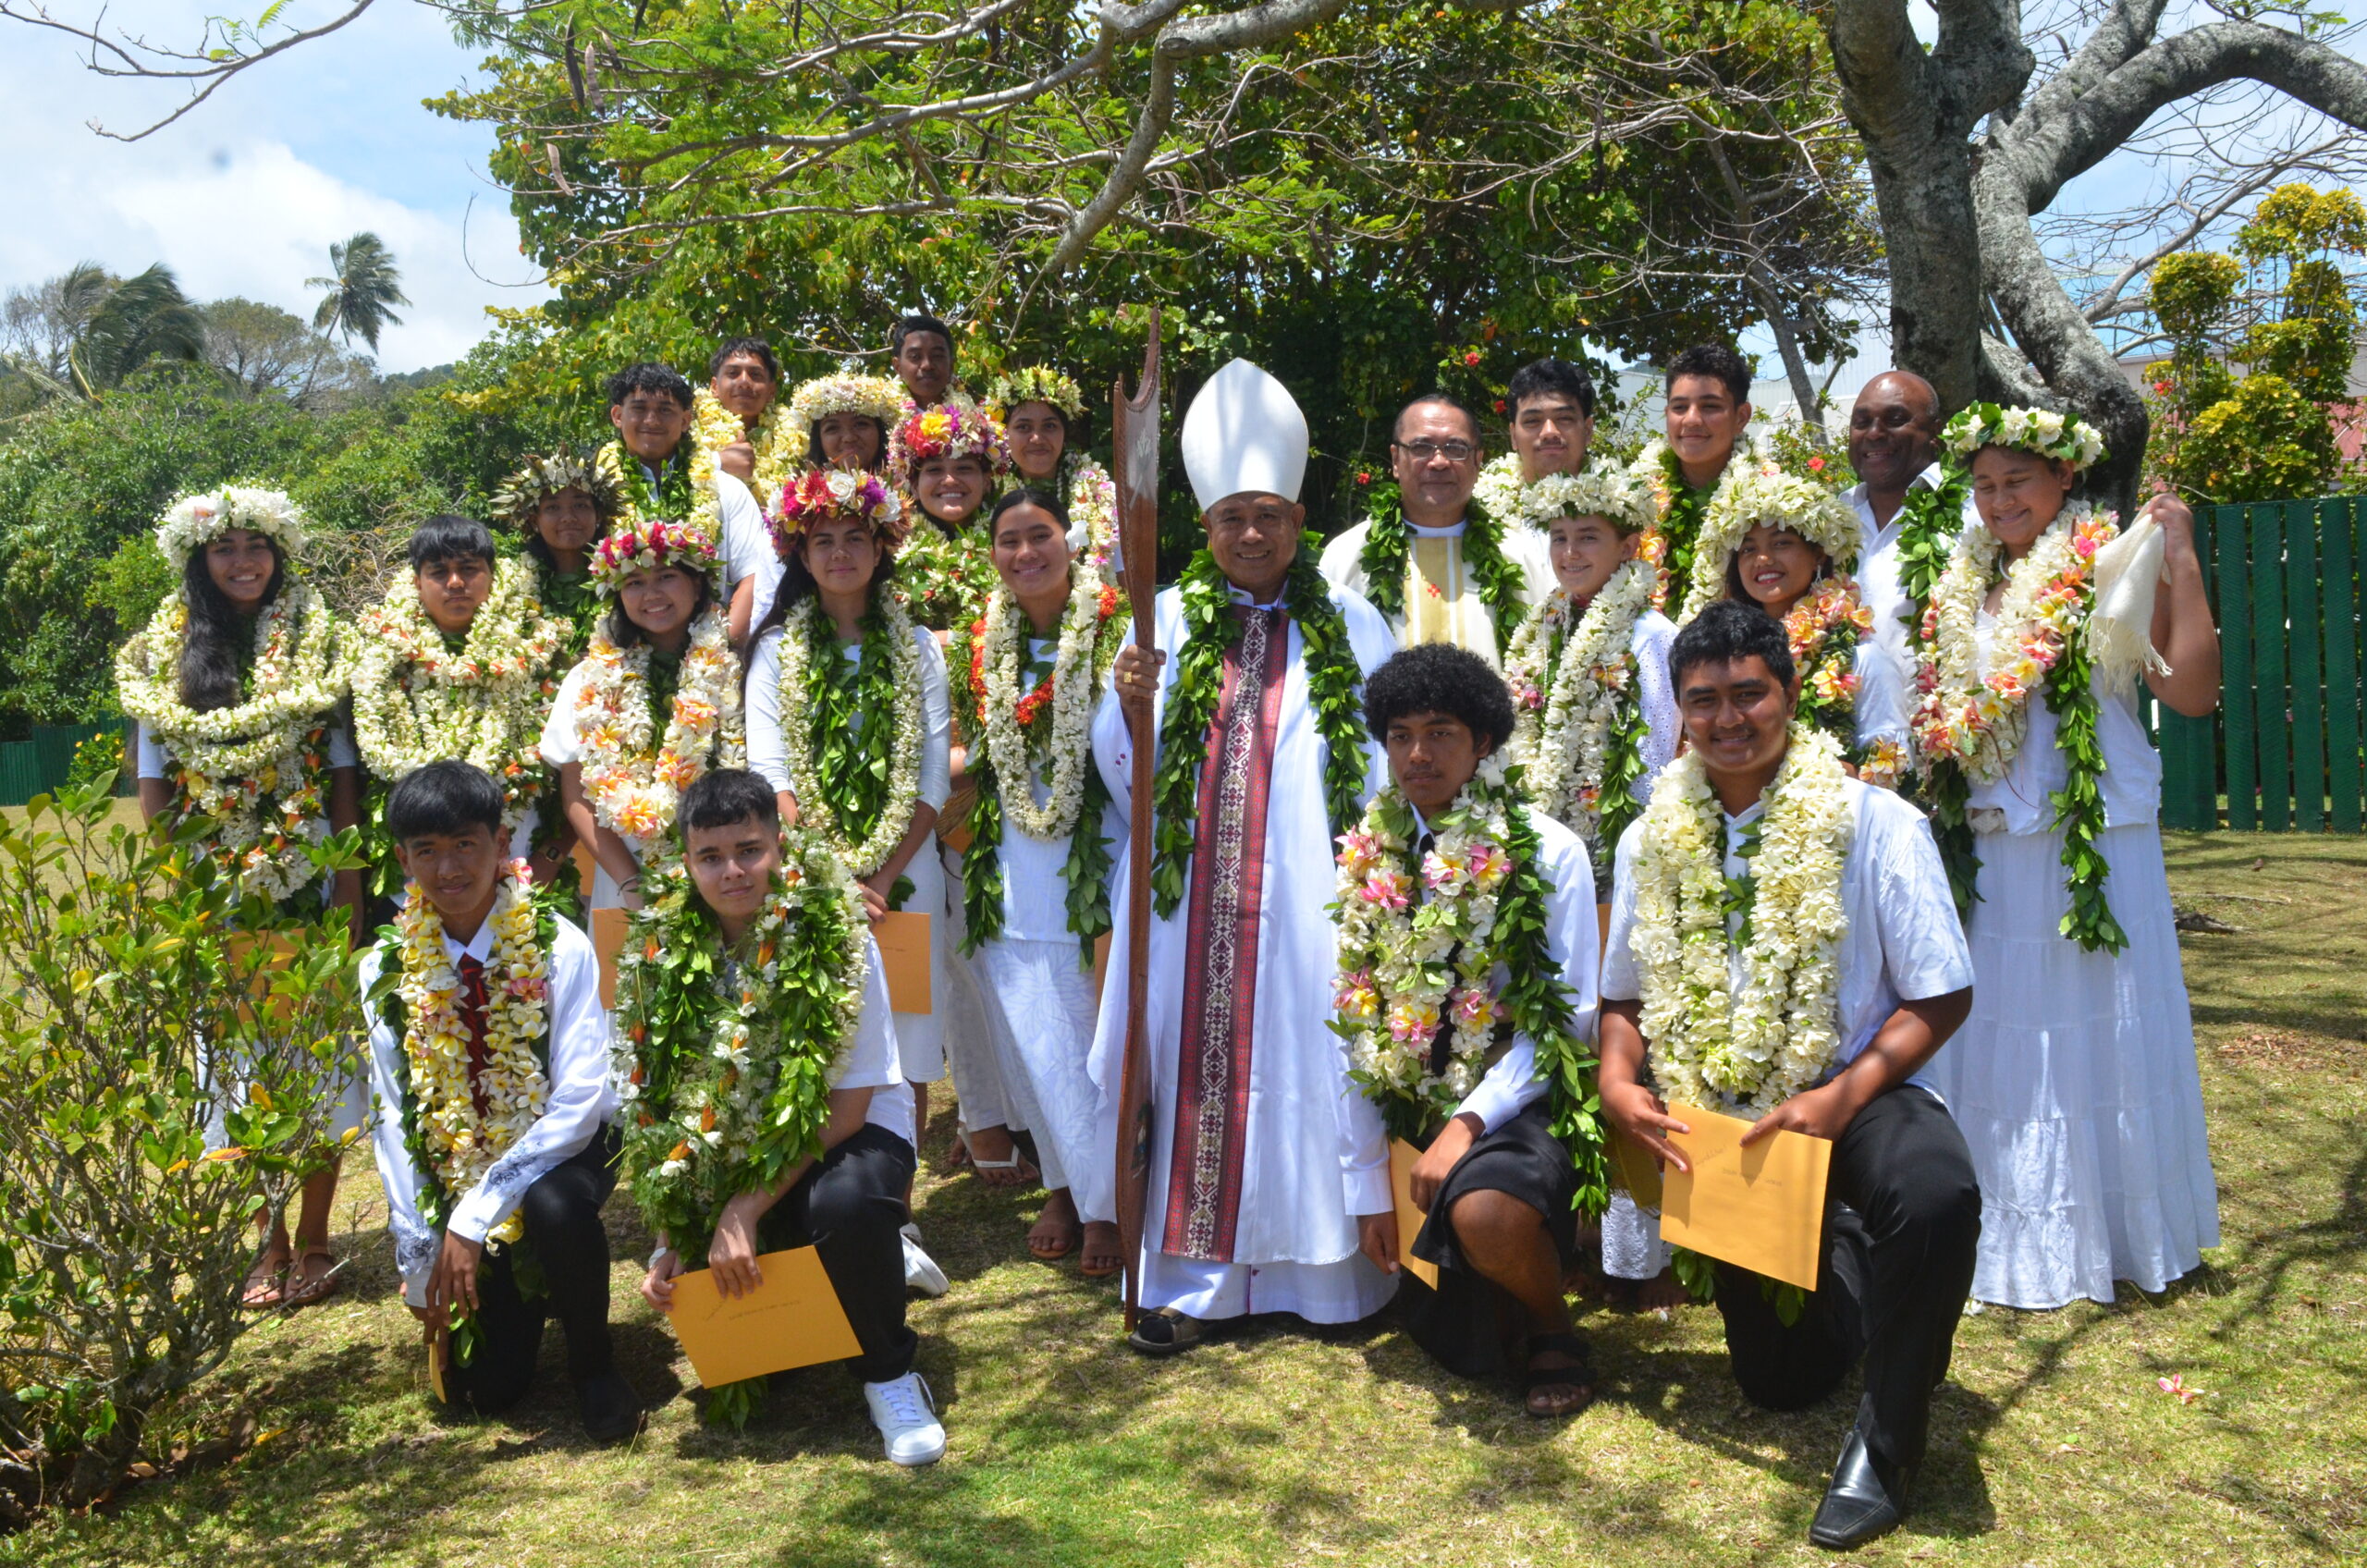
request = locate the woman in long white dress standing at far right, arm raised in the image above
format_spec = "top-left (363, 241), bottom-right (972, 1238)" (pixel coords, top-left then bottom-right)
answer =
top-left (1915, 405), bottom-right (2218, 1307)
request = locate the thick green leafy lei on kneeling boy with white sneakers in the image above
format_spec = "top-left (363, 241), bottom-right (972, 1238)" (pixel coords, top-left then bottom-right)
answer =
top-left (616, 843), bottom-right (871, 1268)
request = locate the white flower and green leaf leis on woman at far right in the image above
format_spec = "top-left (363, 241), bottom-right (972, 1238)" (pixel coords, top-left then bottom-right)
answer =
top-left (1915, 502), bottom-right (2128, 952)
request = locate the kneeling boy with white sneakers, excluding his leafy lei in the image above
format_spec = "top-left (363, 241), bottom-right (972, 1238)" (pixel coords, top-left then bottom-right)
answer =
top-left (642, 767), bottom-right (944, 1464)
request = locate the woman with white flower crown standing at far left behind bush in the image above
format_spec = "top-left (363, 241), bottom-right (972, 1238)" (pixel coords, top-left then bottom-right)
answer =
top-left (116, 485), bottom-right (369, 1307)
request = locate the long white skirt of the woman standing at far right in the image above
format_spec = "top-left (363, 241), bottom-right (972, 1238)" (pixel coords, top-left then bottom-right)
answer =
top-left (1927, 822), bottom-right (2220, 1310)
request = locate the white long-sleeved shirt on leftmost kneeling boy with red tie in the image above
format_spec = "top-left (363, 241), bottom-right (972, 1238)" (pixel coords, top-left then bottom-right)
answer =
top-left (362, 919), bottom-right (618, 1307)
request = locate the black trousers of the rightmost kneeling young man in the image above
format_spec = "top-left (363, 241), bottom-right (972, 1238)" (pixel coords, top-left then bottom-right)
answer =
top-left (1719, 1084), bottom-right (1981, 1483)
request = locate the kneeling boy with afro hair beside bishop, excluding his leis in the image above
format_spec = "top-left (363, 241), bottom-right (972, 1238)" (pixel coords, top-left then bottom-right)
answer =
top-left (1364, 644), bottom-right (1600, 1416)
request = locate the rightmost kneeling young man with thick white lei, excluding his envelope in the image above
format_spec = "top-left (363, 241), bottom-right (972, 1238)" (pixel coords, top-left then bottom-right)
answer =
top-left (1600, 599), bottom-right (1981, 1551)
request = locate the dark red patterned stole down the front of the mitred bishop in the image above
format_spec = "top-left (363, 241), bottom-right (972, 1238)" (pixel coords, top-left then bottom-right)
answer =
top-left (1159, 604), bottom-right (1290, 1263)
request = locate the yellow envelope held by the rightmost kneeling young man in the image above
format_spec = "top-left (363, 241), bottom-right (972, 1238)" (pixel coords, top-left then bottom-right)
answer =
top-left (1660, 1106), bottom-right (1832, 1291)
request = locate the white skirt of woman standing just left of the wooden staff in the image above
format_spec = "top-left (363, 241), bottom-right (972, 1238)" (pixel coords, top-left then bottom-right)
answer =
top-left (971, 938), bottom-right (1117, 1219)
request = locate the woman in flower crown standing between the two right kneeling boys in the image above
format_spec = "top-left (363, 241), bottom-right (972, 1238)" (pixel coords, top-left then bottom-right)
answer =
top-left (1505, 464), bottom-right (1686, 1307)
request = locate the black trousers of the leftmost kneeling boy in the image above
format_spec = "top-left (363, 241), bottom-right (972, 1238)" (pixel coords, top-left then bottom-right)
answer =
top-left (445, 1127), bottom-right (618, 1414)
